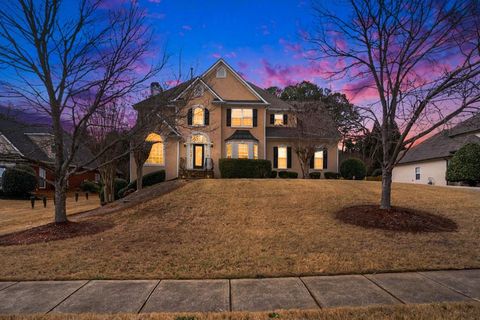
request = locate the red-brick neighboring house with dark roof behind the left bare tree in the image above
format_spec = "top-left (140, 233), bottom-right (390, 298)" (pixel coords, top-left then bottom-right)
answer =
top-left (0, 119), bottom-right (100, 190)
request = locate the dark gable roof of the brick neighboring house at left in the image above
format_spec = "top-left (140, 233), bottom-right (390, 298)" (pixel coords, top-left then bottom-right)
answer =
top-left (0, 118), bottom-right (95, 169)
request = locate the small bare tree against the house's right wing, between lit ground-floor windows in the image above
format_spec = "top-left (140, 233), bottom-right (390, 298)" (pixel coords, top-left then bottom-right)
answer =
top-left (292, 101), bottom-right (340, 179)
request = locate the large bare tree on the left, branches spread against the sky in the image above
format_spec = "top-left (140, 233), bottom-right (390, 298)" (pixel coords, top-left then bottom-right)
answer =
top-left (0, 0), bottom-right (165, 223)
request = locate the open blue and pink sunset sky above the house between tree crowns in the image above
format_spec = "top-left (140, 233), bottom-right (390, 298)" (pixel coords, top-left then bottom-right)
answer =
top-left (96, 0), bottom-right (360, 101)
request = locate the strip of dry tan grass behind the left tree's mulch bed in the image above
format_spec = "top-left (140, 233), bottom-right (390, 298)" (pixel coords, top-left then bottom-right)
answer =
top-left (0, 194), bottom-right (100, 235)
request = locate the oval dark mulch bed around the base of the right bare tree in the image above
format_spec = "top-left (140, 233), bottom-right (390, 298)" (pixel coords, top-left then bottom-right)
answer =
top-left (335, 205), bottom-right (458, 232)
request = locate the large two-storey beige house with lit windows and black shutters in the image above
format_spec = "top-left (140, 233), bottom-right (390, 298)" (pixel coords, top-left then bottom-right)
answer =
top-left (130, 59), bottom-right (339, 180)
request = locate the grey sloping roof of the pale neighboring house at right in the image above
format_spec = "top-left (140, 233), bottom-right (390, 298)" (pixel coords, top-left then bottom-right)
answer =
top-left (399, 114), bottom-right (480, 164)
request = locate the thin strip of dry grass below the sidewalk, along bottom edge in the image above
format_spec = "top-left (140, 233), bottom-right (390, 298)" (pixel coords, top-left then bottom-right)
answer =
top-left (0, 302), bottom-right (480, 320)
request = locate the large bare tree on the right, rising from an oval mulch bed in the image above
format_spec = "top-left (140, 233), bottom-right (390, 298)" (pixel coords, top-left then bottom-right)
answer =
top-left (310, 0), bottom-right (480, 209)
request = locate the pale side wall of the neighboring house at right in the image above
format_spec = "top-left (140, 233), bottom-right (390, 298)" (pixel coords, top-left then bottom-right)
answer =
top-left (392, 159), bottom-right (447, 186)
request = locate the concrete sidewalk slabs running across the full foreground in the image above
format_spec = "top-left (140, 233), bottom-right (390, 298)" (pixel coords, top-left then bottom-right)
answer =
top-left (0, 269), bottom-right (480, 314)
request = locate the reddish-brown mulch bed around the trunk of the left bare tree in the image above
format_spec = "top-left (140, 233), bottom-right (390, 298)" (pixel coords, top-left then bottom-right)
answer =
top-left (0, 220), bottom-right (113, 246)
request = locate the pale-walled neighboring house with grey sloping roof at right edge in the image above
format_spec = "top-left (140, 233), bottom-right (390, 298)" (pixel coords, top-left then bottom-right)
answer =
top-left (393, 114), bottom-right (480, 186)
